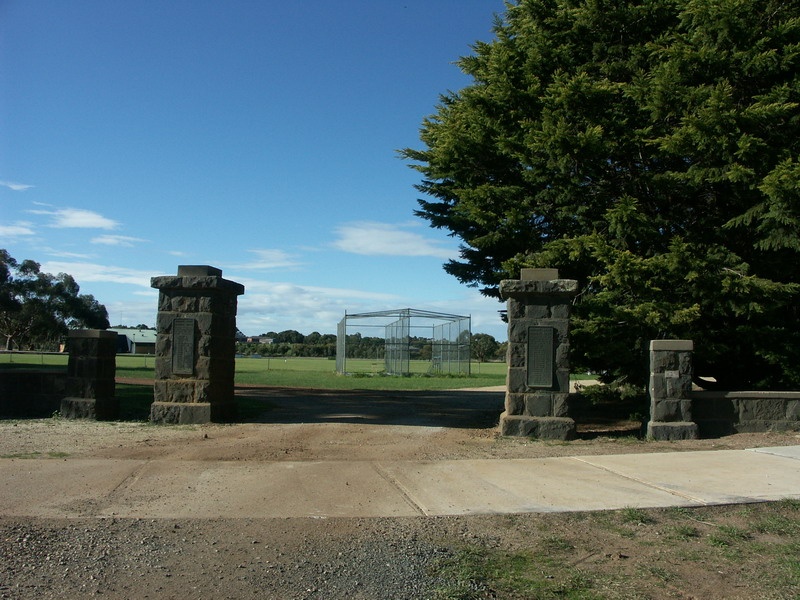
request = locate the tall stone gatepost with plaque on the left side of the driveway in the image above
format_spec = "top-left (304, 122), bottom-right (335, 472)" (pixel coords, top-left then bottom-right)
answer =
top-left (150, 265), bottom-right (244, 423)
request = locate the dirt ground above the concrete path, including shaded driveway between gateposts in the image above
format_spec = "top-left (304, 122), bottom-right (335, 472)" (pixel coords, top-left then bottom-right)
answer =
top-left (0, 388), bottom-right (800, 461)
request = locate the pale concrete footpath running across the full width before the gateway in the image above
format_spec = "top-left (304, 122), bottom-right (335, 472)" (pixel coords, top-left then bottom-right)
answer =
top-left (0, 446), bottom-right (800, 518)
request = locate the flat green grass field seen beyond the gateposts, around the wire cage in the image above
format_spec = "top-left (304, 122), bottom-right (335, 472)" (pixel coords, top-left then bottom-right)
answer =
top-left (0, 353), bottom-right (506, 390)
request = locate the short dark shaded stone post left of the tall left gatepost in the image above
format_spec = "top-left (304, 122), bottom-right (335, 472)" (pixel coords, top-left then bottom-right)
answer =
top-left (60, 329), bottom-right (119, 421)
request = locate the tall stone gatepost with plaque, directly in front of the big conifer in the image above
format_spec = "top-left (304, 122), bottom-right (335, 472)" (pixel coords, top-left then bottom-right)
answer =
top-left (500, 269), bottom-right (578, 440)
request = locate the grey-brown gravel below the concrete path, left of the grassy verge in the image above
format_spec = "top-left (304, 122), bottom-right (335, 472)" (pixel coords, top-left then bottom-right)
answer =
top-left (0, 518), bottom-right (491, 599)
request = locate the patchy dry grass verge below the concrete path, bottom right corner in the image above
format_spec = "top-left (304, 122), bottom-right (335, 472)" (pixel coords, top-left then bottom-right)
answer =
top-left (432, 500), bottom-right (800, 600)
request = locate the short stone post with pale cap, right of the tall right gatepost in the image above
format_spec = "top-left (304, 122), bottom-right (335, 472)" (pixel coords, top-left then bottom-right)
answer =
top-left (647, 340), bottom-right (698, 440)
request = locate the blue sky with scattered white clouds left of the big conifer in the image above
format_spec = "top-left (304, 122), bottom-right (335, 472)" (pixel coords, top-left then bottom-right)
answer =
top-left (0, 0), bottom-right (506, 340)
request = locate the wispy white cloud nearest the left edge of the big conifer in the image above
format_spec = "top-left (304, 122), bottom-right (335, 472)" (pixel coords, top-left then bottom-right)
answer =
top-left (333, 221), bottom-right (456, 259)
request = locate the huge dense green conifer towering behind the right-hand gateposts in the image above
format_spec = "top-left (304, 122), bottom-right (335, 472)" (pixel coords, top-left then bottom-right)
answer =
top-left (401, 0), bottom-right (800, 387)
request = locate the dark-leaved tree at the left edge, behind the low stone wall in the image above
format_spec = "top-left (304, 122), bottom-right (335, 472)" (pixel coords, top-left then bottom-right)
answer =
top-left (0, 249), bottom-right (108, 350)
